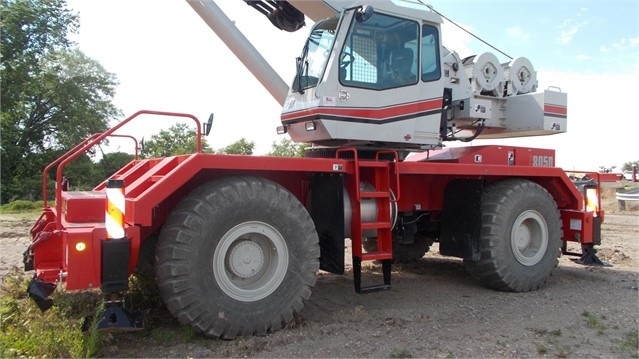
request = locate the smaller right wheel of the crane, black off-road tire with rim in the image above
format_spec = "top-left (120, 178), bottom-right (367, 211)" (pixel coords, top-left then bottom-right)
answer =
top-left (464, 179), bottom-right (561, 292)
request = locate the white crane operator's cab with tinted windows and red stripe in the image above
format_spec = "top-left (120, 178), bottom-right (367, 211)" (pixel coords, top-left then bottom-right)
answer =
top-left (280, 2), bottom-right (444, 149)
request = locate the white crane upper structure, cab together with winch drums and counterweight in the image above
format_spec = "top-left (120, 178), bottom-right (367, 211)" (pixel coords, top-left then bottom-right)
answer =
top-left (278, 0), bottom-right (567, 151)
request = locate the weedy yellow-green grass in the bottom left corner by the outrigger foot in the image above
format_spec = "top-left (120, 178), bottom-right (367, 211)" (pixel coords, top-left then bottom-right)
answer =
top-left (0, 269), bottom-right (176, 358)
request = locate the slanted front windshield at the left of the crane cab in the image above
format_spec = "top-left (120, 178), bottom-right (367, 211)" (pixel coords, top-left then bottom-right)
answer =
top-left (291, 17), bottom-right (338, 93)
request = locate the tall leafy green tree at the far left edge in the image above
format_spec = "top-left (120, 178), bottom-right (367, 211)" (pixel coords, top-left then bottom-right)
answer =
top-left (0, 0), bottom-right (120, 203)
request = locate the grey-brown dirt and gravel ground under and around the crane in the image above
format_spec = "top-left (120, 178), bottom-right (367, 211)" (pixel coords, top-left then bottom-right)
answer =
top-left (0, 187), bottom-right (639, 358)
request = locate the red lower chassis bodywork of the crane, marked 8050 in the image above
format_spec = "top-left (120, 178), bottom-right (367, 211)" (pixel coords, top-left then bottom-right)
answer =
top-left (30, 129), bottom-right (603, 289)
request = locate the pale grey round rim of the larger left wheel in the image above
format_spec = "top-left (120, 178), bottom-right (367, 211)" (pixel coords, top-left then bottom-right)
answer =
top-left (213, 222), bottom-right (288, 302)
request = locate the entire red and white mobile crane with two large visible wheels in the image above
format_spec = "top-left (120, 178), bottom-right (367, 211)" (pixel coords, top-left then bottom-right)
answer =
top-left (24, 0), bottom-right (604, 338)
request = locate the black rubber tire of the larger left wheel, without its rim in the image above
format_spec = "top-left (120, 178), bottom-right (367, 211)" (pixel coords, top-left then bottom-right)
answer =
top-left (156, 176), bottom-right (320, 339)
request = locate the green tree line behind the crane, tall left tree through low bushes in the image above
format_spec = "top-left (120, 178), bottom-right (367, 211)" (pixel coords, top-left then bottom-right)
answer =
top-left (0, 0), bottom-right (305, 204)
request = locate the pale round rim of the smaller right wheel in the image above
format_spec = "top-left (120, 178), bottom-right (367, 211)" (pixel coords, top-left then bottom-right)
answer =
top-left (510, 210), bottom-right (548, 266)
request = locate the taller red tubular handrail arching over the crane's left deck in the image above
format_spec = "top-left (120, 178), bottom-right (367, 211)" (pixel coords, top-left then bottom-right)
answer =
top-left (45, 110), bottom-right (202, 230)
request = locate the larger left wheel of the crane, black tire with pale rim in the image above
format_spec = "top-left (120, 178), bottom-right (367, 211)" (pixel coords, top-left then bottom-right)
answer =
top-left (156, 176), bottom-right (320, 339)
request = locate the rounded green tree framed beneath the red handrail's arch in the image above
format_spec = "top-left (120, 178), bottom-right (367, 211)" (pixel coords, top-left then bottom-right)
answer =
top-left (140, 123), bottom-right (213, 158)
